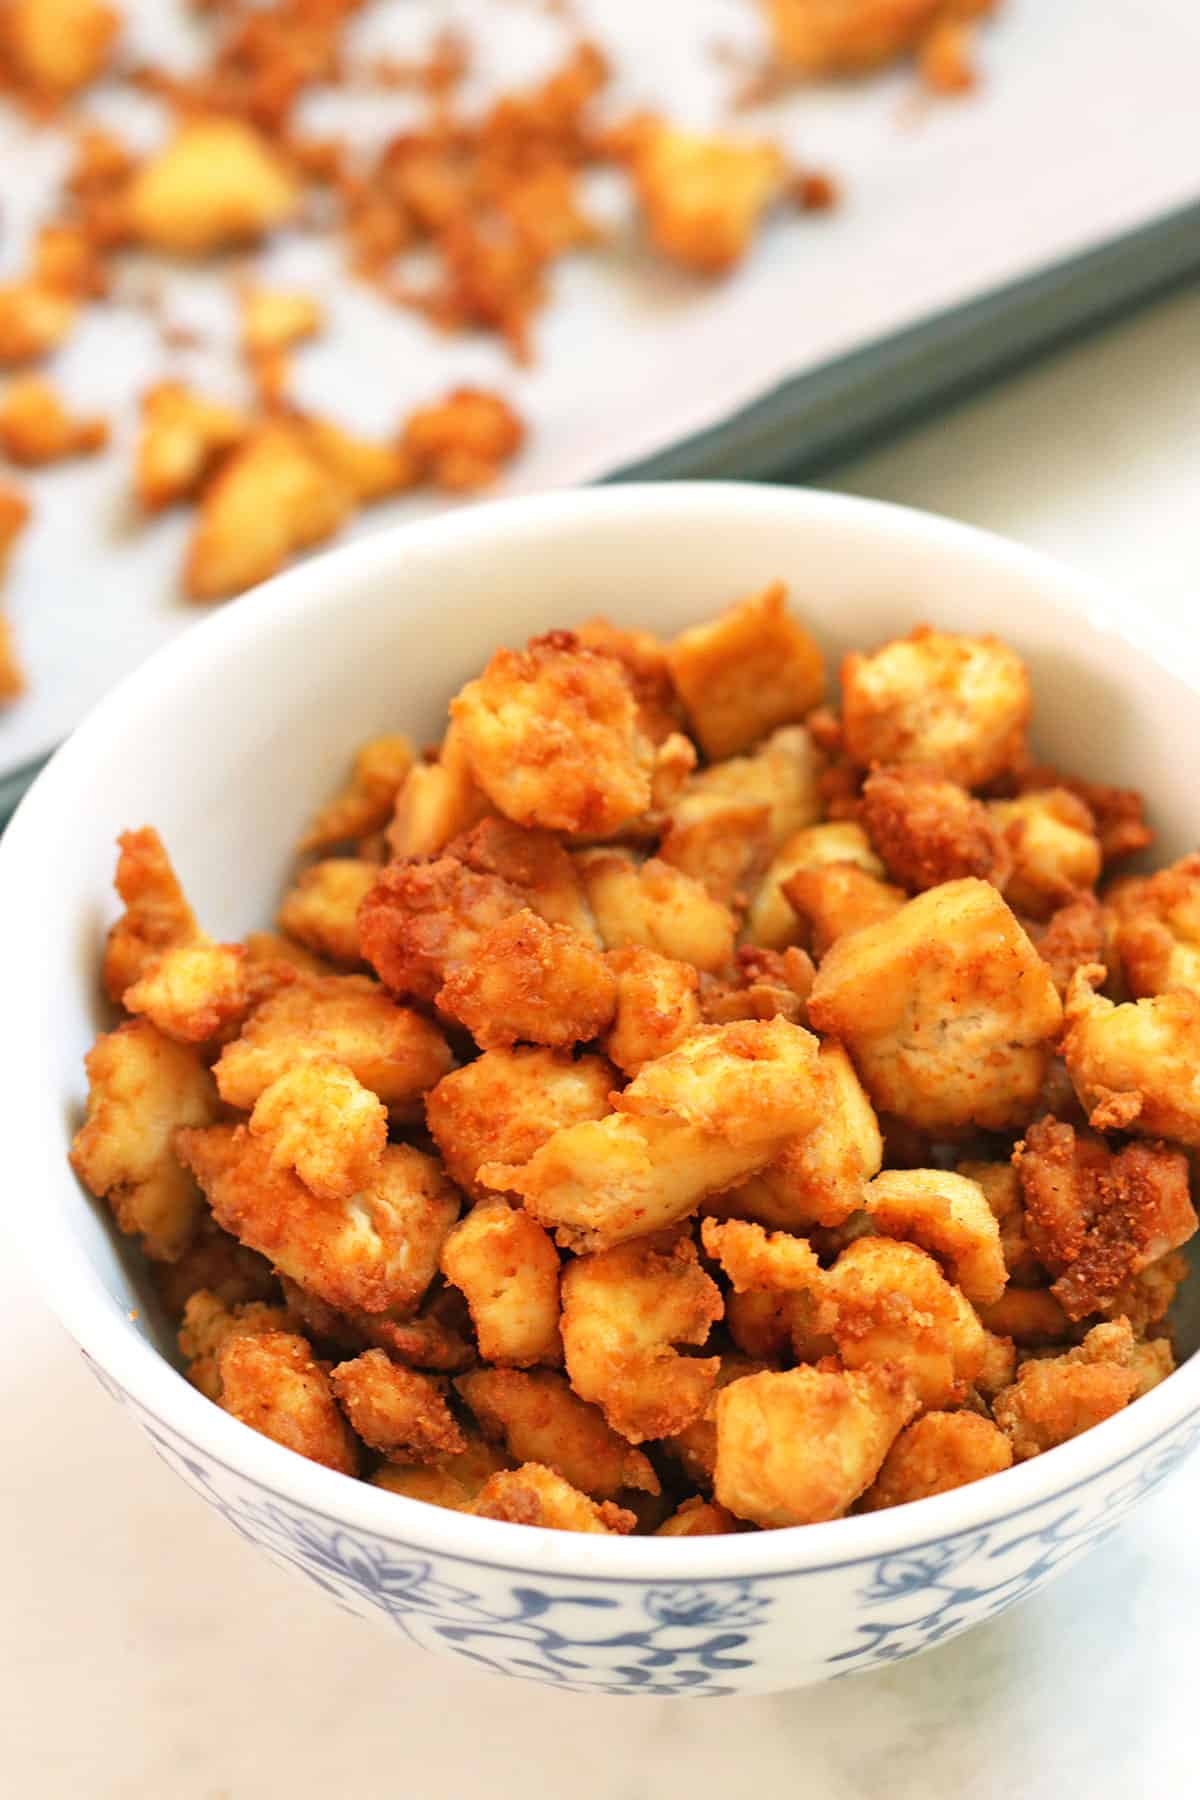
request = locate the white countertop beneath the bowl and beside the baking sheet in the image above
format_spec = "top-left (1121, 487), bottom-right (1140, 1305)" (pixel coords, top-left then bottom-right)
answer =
top-left (9, 293), bottom-right (1200, 1800)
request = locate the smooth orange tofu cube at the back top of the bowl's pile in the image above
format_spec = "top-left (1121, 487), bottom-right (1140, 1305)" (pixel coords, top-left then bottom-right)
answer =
top-left (667, 581), bottom-right (826, 761)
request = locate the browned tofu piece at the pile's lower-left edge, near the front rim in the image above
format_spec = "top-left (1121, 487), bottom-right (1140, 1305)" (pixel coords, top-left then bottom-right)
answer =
top-left (218, 1332), bottom-right (358, 1474)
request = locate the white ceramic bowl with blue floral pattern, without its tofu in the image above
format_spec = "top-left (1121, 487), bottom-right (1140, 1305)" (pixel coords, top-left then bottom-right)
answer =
top-left (0, 484), bottom-right (1200, 1696)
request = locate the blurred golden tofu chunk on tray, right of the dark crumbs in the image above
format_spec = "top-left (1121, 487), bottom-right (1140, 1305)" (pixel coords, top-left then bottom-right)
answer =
top-left (630, 119), bottom-right (786, 275)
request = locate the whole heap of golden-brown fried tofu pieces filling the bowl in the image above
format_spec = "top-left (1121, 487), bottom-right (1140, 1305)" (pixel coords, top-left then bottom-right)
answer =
top-left (70, 590), bottom-right (1200, 1537)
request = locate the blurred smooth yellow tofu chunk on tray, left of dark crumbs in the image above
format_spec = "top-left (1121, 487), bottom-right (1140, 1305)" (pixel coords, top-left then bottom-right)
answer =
top-left (126, 117), bottom-right (300, 256)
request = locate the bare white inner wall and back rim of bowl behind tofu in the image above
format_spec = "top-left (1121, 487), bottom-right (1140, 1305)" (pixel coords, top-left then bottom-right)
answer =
top-left (9, 486), bottom-right (1200, 1375)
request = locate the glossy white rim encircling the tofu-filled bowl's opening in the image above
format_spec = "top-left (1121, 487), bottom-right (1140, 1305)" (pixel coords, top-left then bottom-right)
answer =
top-left (9, 482), bottom-right (1200, 1584)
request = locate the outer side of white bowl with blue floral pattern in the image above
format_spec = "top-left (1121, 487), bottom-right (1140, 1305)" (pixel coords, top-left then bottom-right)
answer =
top-left (82, 1363), bottom-right (1200, 1697)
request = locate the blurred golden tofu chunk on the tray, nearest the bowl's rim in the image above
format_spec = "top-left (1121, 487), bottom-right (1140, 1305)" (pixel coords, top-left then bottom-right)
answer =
top-left (184, 421), bottom-right (354, 599)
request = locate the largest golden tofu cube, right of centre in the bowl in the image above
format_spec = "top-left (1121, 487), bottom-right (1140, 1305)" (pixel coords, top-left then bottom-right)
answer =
top-left (808, 880), bottom-right (1061, 1130)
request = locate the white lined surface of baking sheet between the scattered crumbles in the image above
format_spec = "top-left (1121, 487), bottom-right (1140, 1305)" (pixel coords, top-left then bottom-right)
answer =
top-left (0, 0), bottom-right (1200, 770)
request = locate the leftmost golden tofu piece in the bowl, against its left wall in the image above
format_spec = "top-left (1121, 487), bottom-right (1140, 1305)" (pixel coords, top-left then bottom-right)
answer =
top-left (70, 1019), bottom-right (219, 1262)
